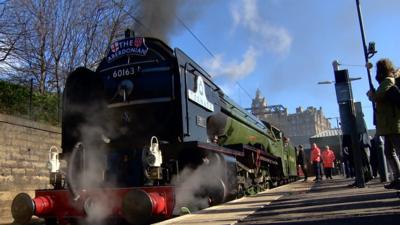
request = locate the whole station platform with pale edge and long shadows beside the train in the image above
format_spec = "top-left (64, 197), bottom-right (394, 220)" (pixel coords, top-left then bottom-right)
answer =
top-left (157, 176), bottom-right (400, 225)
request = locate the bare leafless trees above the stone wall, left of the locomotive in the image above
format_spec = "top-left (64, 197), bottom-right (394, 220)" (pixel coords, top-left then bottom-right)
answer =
top-left (0, 0), bottom-right (136, 94)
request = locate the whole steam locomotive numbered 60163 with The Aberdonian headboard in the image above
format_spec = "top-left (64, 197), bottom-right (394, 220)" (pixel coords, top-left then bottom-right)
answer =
top-left (12, 31), bottom-right (297, 224)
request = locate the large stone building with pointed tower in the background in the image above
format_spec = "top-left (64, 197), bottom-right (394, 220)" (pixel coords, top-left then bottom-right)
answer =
top-left (251, 90), bottom-right (331, 148)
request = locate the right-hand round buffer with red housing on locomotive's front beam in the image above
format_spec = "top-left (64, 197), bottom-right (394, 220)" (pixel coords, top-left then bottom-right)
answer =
top-left (122, 189), bottom-right (167, 225)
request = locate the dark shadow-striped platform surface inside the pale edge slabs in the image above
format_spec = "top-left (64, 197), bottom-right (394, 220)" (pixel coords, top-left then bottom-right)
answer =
top-left (237, 178), bottom-right (400, 225)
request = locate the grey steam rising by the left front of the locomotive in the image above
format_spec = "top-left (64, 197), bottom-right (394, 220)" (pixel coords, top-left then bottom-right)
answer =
top-left (67, 95), bottom-right (116, 225)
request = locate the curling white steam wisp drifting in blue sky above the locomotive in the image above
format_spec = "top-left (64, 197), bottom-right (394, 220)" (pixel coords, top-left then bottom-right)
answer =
top-left (205, 0), bottom-right (292, 81)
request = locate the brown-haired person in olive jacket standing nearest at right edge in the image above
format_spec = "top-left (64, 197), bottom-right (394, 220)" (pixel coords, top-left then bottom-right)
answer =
top-left (367, 59), bottom-right (400, 189)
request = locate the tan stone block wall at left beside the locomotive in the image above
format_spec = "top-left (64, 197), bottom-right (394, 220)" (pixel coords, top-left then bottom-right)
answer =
top-left (0, 114), bottom-right (61, 224)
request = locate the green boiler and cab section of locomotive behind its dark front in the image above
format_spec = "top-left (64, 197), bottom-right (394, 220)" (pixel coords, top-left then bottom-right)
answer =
top-left (207, 93), bottom-right (297, 189)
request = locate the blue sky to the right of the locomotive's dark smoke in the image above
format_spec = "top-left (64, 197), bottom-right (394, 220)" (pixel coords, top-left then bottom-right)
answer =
top-left (170, 0), bottom-right (400, 129)
